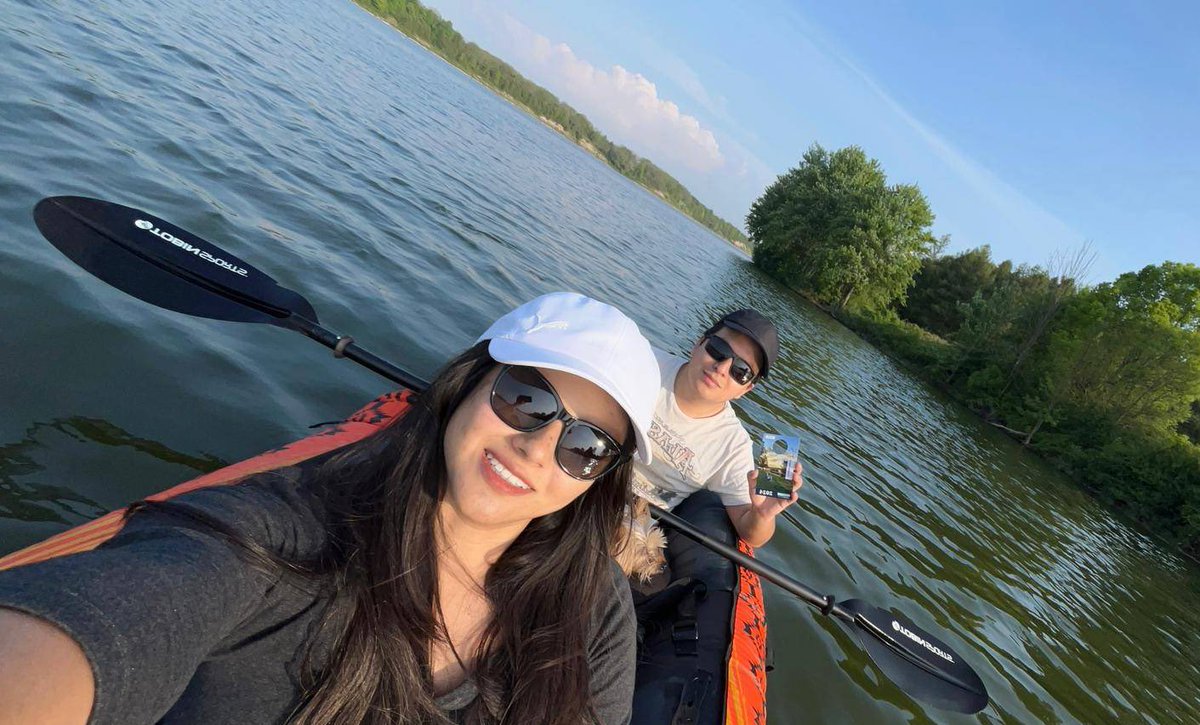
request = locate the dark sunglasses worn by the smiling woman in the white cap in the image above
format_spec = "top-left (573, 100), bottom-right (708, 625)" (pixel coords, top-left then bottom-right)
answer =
top-left (492, 365), bottom-right (630, 481)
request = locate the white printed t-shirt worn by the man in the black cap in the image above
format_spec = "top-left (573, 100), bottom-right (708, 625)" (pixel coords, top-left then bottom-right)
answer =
top-left (634, 350), bottom-right (754, 510)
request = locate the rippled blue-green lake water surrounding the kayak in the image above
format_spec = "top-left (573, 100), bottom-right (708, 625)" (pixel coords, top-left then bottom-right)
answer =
top-left (0, 0), bottom-right (1200, 723)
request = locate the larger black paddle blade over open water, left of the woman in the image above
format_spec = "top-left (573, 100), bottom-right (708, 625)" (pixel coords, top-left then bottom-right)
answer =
top-left (34, 197), bottom-right (317, 326)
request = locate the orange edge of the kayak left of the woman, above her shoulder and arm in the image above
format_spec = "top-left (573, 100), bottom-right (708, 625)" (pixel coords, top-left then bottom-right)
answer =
top-left (0, 390), bottom-right (412, 571)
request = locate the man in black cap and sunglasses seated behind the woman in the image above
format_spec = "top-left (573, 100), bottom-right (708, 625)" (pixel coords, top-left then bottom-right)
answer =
top-left (634, 310), bottom-right (803, 546)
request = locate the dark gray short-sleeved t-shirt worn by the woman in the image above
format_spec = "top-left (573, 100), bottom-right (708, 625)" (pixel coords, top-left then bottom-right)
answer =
top-left (0, 468), bottom-right (636, 725)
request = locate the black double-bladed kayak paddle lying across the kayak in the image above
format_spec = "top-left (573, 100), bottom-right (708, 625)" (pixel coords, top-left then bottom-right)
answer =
top-left (34, 197), bottom-right (988, 713)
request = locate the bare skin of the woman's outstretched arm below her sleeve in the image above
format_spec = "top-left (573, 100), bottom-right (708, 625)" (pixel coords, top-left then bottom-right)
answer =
top-left (0, 607), bottom-right (96, 725)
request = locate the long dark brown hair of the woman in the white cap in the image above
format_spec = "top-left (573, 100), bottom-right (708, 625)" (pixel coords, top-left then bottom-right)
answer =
top-left (144, 342), bottom-right (632, 725)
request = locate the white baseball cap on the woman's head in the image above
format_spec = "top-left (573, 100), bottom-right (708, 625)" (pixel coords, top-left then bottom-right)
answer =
top-left (476, 292), bottom-right (660, 463)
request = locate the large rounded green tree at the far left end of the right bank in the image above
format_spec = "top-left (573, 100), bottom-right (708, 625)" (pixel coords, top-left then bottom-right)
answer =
top-left (746, 144), bottom-right (937, 310)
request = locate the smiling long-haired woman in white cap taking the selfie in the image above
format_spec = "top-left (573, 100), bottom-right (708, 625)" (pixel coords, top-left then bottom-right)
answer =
top-left (0, 293), bottom-right (658, 725)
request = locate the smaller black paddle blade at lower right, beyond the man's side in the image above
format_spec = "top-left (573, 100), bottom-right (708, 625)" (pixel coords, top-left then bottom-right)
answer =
top-left (839, 599), bottom-right (988, 713)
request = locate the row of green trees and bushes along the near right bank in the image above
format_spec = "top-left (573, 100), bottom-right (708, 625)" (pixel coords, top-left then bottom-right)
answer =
top-left (746, 145), bottom-right (1200, 555)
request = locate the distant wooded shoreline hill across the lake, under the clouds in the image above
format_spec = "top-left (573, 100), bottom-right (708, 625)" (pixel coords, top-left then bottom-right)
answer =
top-left (355, 0), bottom-right (750, 252)
